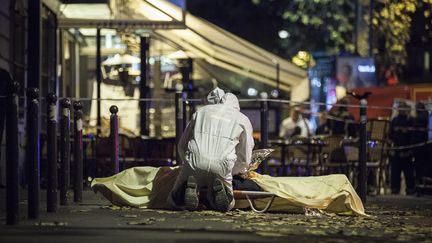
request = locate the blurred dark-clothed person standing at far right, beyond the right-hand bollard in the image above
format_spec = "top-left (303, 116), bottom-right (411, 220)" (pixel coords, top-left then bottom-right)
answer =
top-left (390, 102), bottom-right (414, 195)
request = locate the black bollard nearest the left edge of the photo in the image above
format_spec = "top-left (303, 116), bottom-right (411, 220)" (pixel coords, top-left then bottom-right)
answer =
top-left (6, 81), bottom-right (19, 225)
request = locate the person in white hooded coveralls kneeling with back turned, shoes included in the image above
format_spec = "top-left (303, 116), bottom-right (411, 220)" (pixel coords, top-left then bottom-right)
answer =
top-left (168, 88), bottom-right (254, 212)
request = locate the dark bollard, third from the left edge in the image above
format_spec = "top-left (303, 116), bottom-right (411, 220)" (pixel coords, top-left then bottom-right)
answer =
top-left (46, 93), bottom-right (58, 212)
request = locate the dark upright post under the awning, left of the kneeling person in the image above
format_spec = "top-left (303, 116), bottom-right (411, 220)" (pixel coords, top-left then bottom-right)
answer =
top-left (139, 37), bottom-right (150, 136)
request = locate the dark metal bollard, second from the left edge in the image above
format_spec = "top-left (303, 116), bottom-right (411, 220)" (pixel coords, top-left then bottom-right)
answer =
top-left (27, 88), bottom-right (40, 219)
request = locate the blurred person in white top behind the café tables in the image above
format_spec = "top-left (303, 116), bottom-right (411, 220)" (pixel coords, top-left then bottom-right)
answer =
top-left (279, 106), bottom-right (312, 139)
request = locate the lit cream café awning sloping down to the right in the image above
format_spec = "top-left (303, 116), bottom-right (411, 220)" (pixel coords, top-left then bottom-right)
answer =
top-left (54, 0), bottom-right (309, 101)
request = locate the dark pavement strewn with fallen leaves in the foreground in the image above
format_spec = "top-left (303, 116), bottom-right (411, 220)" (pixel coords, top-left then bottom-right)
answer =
top-left (0, 189), bottom-right (432, 243)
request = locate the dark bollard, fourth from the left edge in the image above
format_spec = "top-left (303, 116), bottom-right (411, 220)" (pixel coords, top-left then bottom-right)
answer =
top-left (60, 98), bottom-right (71, 205)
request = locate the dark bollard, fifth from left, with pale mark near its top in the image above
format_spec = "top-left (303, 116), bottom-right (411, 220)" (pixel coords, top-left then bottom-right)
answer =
top-left (73, 101), bottom-right (83, 202)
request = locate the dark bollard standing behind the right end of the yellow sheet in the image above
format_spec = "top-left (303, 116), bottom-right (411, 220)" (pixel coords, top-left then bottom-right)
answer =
top-left (358, 99), bottom-right (367, 203)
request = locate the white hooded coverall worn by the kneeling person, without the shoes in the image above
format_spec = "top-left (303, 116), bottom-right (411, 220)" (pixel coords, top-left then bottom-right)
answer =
top-left (169, 89), bottom-right (254, 209)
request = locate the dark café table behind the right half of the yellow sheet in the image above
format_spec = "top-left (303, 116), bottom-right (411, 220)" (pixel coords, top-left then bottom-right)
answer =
top-left (269, 136), bottom-right (326, 176)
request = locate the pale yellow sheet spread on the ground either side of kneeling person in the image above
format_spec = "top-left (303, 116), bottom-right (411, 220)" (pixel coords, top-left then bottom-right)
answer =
top-left (91, 166), bottom-right (365, 215)
